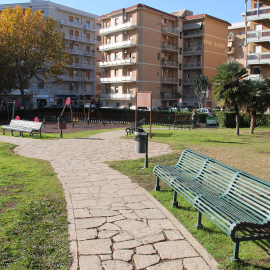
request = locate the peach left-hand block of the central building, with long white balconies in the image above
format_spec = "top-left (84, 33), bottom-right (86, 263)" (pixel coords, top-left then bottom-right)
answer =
top-left (99, 4), bottom-right (183, 107)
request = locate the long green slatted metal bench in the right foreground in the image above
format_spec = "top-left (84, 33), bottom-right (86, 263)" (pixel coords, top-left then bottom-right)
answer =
top-left (153, 149), bottom-right (270, 261)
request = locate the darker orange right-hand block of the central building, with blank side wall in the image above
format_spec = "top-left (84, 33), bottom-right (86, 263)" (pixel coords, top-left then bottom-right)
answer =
top-left (180, 11), bottom-right (230, 108)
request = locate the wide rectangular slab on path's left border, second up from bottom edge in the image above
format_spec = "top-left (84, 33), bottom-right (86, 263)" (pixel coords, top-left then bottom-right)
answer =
top-left (78, 239), bottom-right (112, 255)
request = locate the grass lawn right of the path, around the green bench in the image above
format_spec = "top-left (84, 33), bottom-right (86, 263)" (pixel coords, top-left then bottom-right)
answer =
top-left (109, 128), bottom-right (270, 269)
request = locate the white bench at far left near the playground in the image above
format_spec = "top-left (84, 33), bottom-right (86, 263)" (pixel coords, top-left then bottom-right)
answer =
top-left (2, 119), bottom-right (43, 138)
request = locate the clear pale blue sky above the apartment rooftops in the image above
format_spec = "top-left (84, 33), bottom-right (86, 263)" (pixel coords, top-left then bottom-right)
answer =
top-left (0, 0), bottom-right (250, 23)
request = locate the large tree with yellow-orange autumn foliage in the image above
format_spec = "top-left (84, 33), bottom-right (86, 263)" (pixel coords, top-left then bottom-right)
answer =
top-left (0, 6), bottom-right (69, 106)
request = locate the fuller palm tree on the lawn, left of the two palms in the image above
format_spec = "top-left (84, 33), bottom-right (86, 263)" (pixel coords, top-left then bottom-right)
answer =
top-left (212, 61), bottom-right (249, 135)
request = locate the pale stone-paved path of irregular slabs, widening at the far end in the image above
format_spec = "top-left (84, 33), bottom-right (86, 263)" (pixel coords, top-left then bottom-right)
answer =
top-left (0, 130), bottom-right (217, 270)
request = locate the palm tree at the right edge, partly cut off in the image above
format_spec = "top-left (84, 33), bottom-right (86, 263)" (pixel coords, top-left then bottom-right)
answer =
top-left (245, 78), bottom-right (270, 134)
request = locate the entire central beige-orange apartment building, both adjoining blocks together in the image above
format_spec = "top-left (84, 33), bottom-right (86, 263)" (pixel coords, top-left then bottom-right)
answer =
top-left (99, 4), bottom-right (230, 107)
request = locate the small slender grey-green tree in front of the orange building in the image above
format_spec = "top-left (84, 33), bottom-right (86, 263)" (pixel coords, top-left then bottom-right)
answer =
top-left (192, 75), bottom-right (212, 107)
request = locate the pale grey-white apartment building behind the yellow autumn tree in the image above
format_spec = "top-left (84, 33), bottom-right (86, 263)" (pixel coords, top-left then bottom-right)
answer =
top-left (0, 0), bottom-right (101, 106)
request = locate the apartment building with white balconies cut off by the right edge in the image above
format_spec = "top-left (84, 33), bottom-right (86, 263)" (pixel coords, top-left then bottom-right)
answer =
top-left (242, 0), bottom-right (270, 79)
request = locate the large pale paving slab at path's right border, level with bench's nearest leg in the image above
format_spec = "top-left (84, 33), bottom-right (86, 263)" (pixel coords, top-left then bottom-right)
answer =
top-left (154, 240), bottom-right (199, 260)
